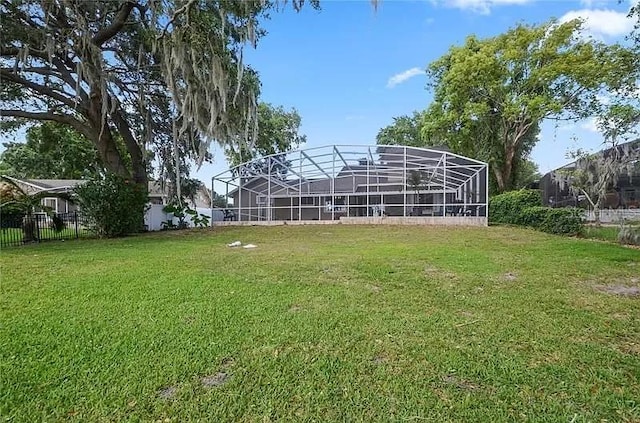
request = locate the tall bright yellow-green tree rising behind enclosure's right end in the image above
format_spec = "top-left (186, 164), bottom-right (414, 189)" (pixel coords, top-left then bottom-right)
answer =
top-left (422, 20), bottom-right (638, 192)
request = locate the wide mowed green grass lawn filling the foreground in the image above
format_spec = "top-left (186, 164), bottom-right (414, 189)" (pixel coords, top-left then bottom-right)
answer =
top-left (0, 225), bottom-right (640, 422)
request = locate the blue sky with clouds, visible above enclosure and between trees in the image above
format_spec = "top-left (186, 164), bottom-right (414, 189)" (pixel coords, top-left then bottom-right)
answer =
top-left (194, 0), bottom-right (633, 184)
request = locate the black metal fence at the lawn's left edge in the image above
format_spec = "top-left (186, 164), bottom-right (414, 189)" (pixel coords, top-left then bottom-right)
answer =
top-left (0, 212), bottom-right (92, 247)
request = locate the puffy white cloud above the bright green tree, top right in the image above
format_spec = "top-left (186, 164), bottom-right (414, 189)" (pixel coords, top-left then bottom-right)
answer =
top-left (560, 9), bottom-right (633, 38)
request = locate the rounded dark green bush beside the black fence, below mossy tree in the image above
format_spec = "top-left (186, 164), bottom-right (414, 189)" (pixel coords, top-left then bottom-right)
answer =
top-left (74, 174), bottom-right (148, 238)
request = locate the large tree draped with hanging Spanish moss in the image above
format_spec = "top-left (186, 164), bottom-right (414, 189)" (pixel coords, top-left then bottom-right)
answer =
top-left (0, 0), bottom-right (317, 195)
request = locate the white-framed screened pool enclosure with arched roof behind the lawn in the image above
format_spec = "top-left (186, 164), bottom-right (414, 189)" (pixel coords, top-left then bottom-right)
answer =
top-left (212, 145), bottom-right (488, 224)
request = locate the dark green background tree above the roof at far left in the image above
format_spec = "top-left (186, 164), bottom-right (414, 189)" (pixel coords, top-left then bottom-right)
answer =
top-left (0, 122), bottom-right (101, 179)
